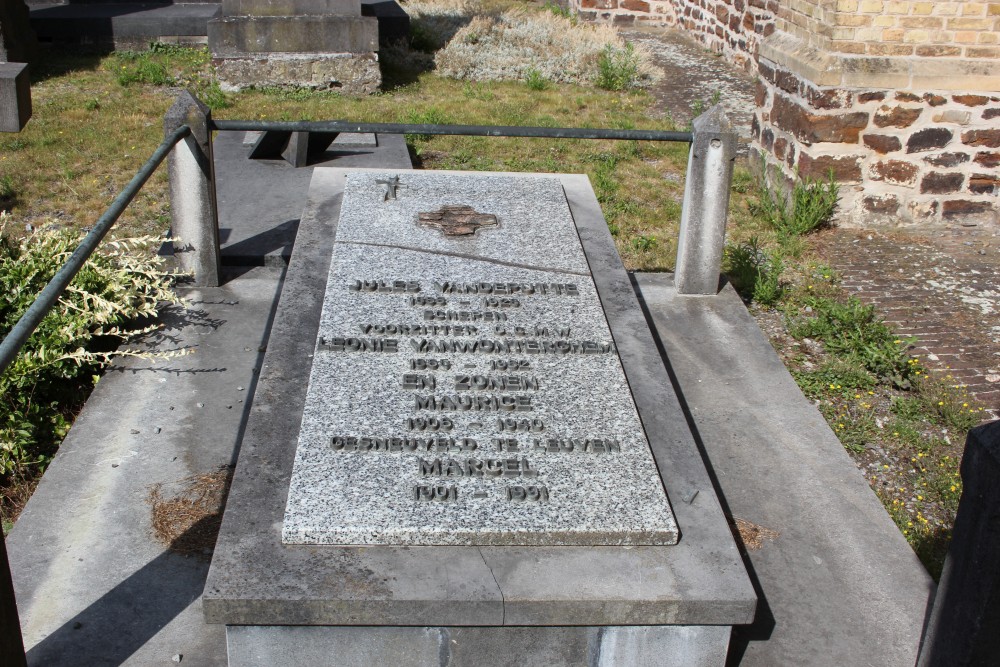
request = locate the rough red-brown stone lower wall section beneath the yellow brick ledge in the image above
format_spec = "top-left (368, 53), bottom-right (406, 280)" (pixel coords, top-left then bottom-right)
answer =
top-left (751, 59), bottom-right (1000, 225)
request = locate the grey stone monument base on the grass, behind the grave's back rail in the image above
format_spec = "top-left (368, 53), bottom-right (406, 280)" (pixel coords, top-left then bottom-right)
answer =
top-left (208, 0), bottom-right (382, 94)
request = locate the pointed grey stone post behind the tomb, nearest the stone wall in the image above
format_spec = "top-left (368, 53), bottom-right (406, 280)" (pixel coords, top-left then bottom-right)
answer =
top-left (674, 104), bottom-right (737, 294)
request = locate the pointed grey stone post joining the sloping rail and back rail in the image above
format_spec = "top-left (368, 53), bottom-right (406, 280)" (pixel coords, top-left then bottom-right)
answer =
top-left (163, 91), bottom-right (220, 287)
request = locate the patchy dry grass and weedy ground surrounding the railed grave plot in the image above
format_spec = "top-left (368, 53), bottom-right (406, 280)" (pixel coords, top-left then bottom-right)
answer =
top-left (0, 9), bottom-right (985, 588)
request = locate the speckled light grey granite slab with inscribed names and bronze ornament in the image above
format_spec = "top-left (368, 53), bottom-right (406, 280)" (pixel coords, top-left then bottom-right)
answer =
top-left (283, 172), bottom-right (677, 546)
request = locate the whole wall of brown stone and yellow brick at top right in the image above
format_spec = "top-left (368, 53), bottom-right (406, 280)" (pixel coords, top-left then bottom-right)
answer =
top-left (572, 0), bottom-right (1000, 225)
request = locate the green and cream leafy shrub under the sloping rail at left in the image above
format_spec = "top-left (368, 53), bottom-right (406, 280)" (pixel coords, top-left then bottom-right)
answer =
top-left (0, 229), bottom-right (177, 479)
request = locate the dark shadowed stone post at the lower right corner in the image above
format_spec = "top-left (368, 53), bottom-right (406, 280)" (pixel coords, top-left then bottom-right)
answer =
top-left (917, 421), bottom-right (1000, 667)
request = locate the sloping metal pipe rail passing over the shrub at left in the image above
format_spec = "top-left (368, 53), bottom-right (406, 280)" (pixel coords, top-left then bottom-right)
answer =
top-left (0, 125), bottom-right (191, 373)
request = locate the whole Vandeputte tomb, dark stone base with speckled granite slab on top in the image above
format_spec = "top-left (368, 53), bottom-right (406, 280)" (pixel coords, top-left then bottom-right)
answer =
top-left (203, 168), bottom-right (756, 666)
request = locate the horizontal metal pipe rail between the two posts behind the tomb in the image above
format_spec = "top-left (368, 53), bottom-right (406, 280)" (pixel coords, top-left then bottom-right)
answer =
top-left (209, 119), bottom-right (694, 143)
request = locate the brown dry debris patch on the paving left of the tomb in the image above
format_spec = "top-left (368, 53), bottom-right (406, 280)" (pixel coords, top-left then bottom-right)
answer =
top-left (147, 466), bottom-right (233, 559)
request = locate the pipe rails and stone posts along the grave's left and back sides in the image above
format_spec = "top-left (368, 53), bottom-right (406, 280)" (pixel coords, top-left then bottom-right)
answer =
top-left (0, 92), bottom-right (736, 666)
